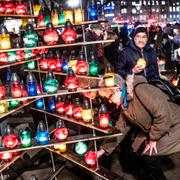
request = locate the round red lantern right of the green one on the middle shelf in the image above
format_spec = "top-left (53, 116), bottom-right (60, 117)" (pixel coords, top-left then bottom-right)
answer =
top-left (64, 67), bottom-right (79, 92)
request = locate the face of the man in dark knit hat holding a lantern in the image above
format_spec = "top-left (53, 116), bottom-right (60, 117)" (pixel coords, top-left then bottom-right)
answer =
top-left (134, 32), bottom-right (148, 49)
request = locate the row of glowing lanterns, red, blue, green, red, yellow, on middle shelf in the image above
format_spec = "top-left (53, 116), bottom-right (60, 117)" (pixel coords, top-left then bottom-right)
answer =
top-left (0, 66), bottom-right (115, 99)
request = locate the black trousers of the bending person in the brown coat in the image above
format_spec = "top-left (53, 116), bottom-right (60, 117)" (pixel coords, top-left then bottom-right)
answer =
top-left (119, 128), bottom-right (167, 180)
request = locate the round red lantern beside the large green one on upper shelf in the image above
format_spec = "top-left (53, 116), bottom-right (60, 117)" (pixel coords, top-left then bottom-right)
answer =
top-left (43, 23), bottom-right (59, 45)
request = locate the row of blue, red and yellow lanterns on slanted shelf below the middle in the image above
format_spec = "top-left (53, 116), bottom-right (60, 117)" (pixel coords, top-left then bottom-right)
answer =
top-left (35, 95), bottom-right (110, 128)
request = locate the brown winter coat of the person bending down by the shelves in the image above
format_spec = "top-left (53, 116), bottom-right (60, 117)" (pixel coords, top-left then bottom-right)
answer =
top-left (101, 76), bottom-right (180, 155)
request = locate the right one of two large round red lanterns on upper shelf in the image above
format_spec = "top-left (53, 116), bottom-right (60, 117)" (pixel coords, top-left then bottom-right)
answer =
top-left (62, 20), bottom-right (77, 44)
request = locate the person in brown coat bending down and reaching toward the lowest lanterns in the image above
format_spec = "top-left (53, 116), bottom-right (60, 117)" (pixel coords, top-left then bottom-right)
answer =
top-left (93, 75), bottom-right (180, 180)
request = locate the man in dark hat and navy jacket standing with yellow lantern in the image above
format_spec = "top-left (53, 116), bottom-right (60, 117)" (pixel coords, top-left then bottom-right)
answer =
top-left (115, 26), bottom-right (159, 81)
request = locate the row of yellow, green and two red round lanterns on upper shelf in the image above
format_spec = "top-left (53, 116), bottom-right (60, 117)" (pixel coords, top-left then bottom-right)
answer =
top-left (0, 20), bottom-right (77, 50)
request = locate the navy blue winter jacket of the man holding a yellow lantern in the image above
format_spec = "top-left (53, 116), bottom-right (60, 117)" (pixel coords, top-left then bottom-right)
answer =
top-left (115, 40), bottom-right (159, 81)
